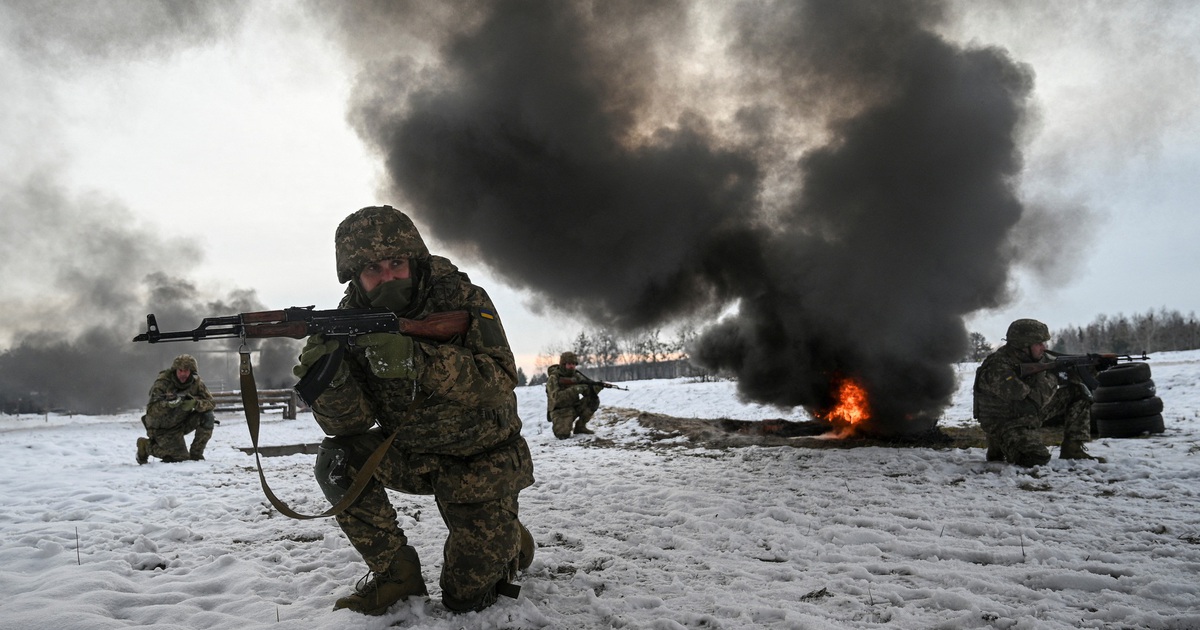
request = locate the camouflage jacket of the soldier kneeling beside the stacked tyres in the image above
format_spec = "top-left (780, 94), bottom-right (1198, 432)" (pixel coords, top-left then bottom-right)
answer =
top-left (973, 344), bottom-right (1058, 424)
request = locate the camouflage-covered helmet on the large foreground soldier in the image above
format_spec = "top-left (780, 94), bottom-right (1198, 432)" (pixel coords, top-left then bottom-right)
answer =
top-left (334, 205), bottom-right (430, 283)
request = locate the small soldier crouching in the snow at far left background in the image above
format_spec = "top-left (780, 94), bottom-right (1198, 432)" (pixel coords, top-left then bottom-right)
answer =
top-left (138, 354), bottom-right (216, 464)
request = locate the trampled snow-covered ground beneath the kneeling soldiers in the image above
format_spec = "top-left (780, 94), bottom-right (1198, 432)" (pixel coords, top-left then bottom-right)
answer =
top-left (0, 352), bottom-right (1200, 630)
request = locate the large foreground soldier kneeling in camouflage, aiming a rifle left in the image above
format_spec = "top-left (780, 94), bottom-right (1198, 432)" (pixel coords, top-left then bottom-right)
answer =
top-left (294, 205), bottom-right (534, 614)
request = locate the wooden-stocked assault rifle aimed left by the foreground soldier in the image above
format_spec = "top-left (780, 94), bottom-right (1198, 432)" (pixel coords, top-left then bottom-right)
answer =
top-left (133, 306), bottom-right (470, 406)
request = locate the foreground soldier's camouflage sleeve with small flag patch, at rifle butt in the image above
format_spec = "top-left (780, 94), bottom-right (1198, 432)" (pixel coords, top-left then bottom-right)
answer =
top-left (415, 284), bottom-right (517, 408)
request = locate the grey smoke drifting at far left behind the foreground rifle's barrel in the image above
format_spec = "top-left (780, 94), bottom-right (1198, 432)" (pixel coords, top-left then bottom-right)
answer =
top-left (0, 175), bottom-right (299, 414)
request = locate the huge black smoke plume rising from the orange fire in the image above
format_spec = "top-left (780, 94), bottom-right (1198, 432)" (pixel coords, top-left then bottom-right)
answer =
top-left (342, 0), bottom-right (1032, 425)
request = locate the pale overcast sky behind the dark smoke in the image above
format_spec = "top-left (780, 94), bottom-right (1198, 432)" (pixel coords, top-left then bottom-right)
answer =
top-left (0, 0), bottom-right (1200, 379)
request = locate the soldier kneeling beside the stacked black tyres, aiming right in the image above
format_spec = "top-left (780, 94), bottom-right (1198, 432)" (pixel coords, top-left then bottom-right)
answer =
top-left (974, 319), bottom-right (1103, 466)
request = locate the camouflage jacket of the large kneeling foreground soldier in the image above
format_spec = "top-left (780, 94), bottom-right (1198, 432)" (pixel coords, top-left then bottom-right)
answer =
top-left (313, 256), bottom-right (532, 456)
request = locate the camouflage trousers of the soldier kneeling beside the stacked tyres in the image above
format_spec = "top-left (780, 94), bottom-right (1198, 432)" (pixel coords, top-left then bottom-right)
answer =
top-left (979, 385), bottom-right (1092, 466)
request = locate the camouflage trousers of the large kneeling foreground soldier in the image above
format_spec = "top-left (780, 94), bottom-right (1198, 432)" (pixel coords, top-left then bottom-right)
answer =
top-left (318, 428), bottom-right (528, 611)
